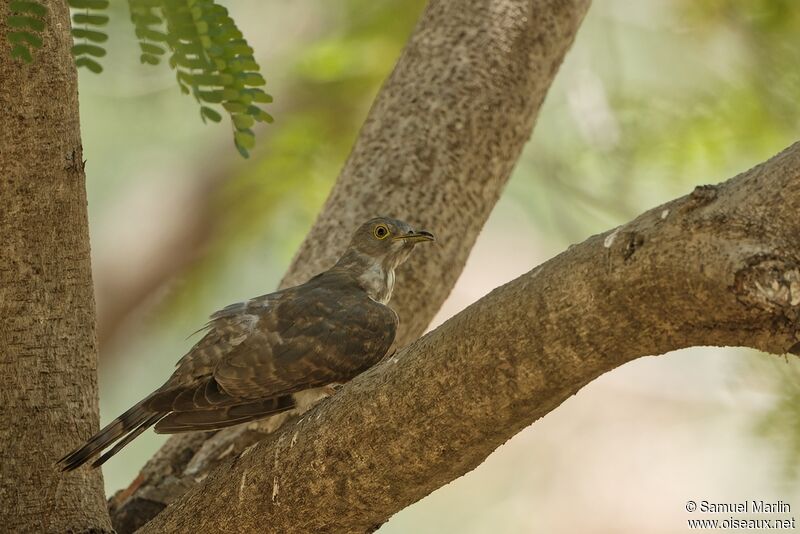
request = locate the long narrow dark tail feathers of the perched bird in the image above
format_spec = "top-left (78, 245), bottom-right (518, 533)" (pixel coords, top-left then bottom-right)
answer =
top-left (57, 399), bottom-right (164, 471)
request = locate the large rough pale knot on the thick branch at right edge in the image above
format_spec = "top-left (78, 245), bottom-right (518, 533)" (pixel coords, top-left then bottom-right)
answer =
top-left (734, 255), bottom-right (800, 321)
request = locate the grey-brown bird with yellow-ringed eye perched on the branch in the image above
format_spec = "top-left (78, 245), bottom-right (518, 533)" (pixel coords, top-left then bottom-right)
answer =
top-left (57, 217), bottom-right (435, 471)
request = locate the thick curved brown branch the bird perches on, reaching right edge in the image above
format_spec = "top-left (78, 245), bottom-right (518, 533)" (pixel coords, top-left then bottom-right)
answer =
top-left (143, 143), bottom-right (800, 533)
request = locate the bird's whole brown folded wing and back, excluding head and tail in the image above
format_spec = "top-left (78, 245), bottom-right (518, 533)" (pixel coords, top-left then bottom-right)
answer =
top-left (147, 277), bottom-right (397, 412)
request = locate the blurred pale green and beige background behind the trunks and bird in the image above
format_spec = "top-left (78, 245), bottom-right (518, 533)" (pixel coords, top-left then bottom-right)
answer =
top-left (80, 0), bottom-right (800, 534)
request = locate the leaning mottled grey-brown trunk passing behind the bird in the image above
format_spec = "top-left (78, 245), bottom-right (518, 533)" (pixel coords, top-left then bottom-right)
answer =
top-left (111, 0), bottom-right (589, 532)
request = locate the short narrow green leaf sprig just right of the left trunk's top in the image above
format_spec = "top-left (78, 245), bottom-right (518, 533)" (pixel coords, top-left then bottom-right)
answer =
top-left (69, 0), bottom-right (108, 74)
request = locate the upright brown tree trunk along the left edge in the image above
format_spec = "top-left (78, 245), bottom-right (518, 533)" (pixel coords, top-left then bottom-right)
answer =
top-left (0, 0), bottom-right (111, 532)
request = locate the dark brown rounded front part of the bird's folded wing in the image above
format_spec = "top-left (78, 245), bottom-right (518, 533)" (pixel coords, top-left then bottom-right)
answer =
top-left (214, 276), bottom-right (397, 399)
